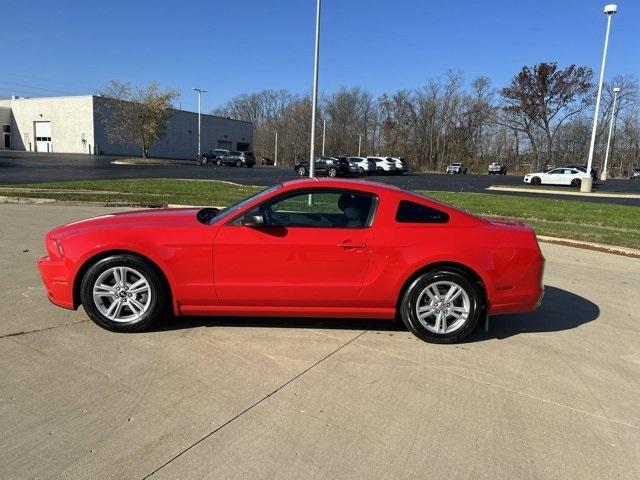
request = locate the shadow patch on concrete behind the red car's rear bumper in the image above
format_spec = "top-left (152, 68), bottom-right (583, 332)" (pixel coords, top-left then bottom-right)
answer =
top-left (462, 285), bottom-right (600, 343)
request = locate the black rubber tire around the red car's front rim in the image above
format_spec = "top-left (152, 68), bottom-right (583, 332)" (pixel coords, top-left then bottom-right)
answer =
top-left (80, 254), bottom-right (169, 332)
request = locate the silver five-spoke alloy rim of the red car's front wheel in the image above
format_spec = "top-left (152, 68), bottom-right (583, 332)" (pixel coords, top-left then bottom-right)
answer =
top-left (93, 267), bottom-right (151, 322)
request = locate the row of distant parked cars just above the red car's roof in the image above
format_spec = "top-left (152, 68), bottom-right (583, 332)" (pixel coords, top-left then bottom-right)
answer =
top-left (293, 156), bottom-right (409, 177)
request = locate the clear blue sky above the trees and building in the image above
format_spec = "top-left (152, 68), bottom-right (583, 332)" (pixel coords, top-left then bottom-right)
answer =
top-left (0, 0), bottom-right (640, 111)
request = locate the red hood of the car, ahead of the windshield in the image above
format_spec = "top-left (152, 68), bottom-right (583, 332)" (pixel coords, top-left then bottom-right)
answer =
top-left (51, 208), bottom-right (200, 237)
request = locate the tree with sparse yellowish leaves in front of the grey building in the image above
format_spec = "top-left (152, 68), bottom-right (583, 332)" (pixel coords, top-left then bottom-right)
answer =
top-left (100, 80), bottom-right (178, 158)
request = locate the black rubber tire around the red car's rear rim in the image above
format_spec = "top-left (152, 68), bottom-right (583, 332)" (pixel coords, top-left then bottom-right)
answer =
top-left (400, 269), bottom-right (484, 343)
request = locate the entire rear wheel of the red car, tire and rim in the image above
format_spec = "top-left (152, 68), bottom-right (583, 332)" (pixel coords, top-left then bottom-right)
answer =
top-left (400, 270), bottom-right (482, 343)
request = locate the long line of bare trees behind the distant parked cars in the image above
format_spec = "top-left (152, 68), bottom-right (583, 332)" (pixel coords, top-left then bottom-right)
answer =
top-left (212, 62), bottom-right (640, 176)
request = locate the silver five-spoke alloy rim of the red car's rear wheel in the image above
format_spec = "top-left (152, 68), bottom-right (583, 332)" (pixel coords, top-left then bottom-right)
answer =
top-left (416, 281), bottom-right (471, 335)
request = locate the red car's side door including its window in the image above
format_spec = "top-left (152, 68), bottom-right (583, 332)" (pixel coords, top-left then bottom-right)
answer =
top-left (213, 189), bottom-right (377, 307)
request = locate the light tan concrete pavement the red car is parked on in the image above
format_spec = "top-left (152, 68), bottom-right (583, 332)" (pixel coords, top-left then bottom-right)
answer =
top-left (0, 204), bottom-right (640, 479)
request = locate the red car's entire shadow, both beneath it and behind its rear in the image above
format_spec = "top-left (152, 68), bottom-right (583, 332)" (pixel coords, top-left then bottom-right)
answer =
top-left (152, 286), bottom-right (600, 343)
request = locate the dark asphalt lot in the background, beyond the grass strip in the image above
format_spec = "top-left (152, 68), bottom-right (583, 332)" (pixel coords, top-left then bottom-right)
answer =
top-left (0, 151), bottom-right (640, 206)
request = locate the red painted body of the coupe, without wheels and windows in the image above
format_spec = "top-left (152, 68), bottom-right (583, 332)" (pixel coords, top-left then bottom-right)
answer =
top-left (38, 179), bottom-right (544, 319)
